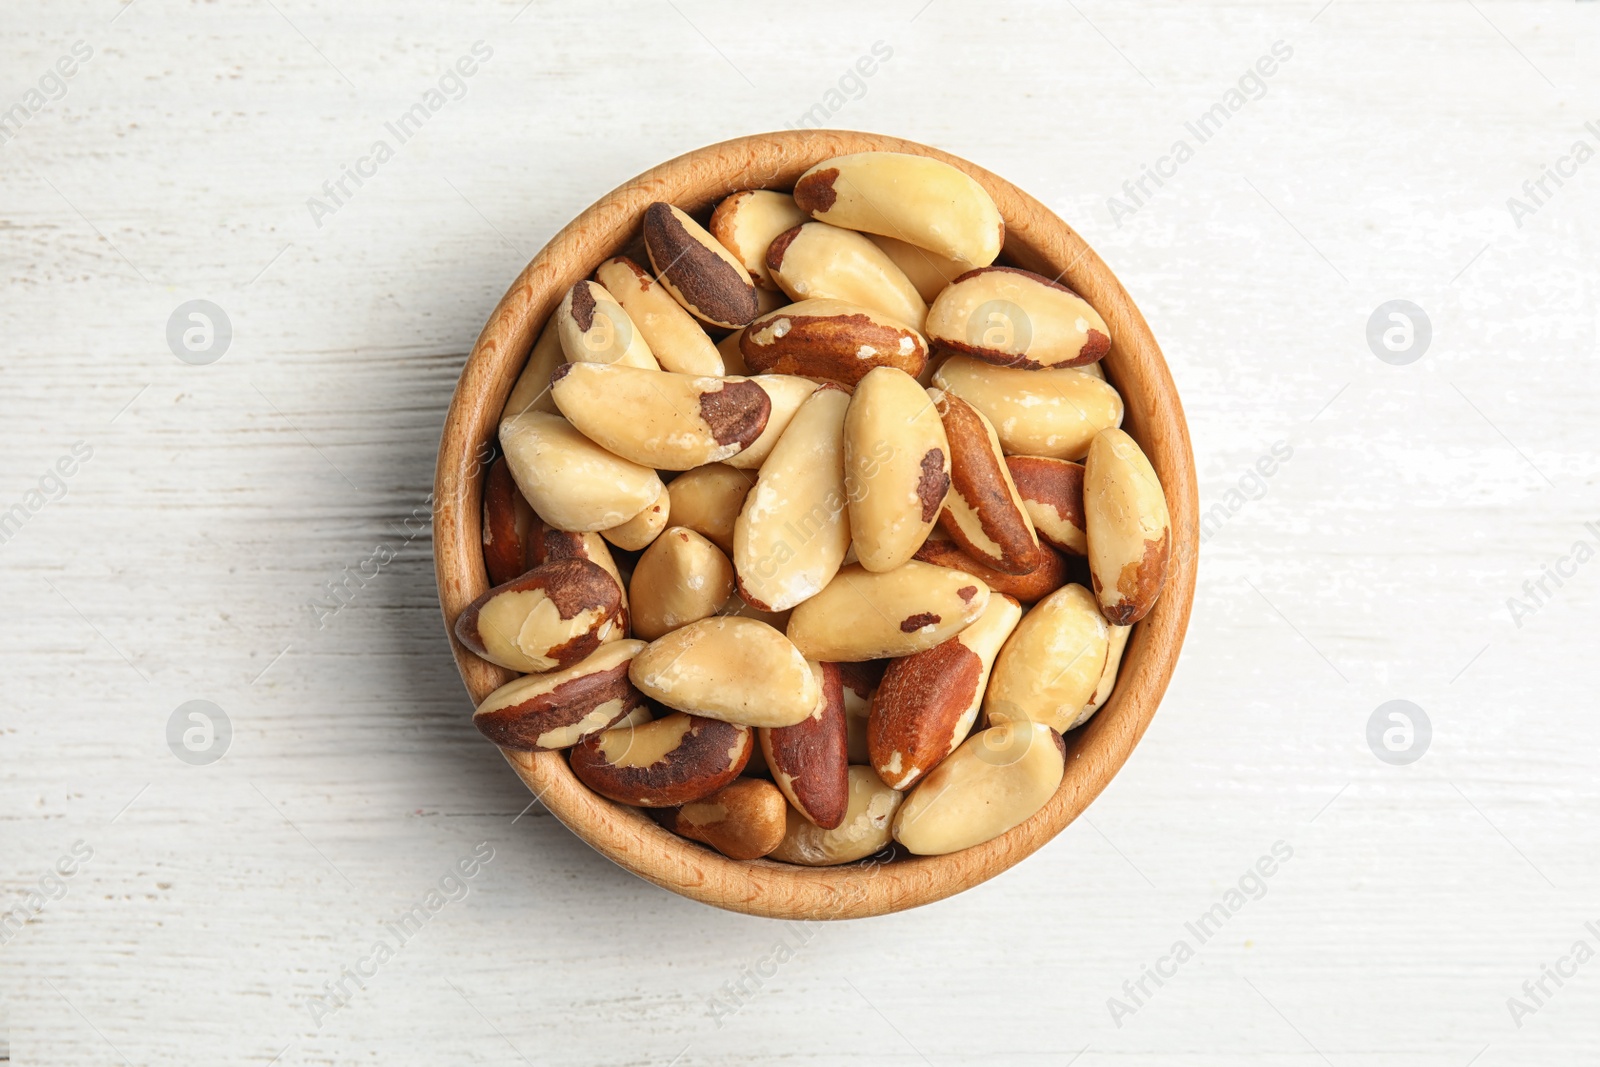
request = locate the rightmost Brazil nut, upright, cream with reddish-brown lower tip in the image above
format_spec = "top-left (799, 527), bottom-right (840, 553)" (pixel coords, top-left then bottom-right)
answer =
top-left (1083, 430), bottom-right (1173, 625)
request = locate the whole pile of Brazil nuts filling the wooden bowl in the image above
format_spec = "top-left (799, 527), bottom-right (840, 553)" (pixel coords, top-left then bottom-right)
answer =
top-left (456, 152), bottom-right (1171, 865)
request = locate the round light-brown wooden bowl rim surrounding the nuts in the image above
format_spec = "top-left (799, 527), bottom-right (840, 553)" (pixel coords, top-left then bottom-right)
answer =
top-left (434, 130), bottom-right (1198, 918)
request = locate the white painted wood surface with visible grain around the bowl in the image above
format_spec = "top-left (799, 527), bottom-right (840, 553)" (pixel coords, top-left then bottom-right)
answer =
top-left (0, 0), bottom-right (1600, 1067)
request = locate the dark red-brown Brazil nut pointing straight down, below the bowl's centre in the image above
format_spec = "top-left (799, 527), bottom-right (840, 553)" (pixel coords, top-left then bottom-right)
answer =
top-left (755, 662), bottom-right (850, 830)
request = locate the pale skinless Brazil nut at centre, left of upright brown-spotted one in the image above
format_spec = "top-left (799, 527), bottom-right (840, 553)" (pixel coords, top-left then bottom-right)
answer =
top-left (733, 387), bottom-right (850, 614)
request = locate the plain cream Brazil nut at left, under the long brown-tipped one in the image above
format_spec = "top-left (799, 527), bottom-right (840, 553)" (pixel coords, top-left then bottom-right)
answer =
top-left (499, 412), bottom-right (661, 533)
